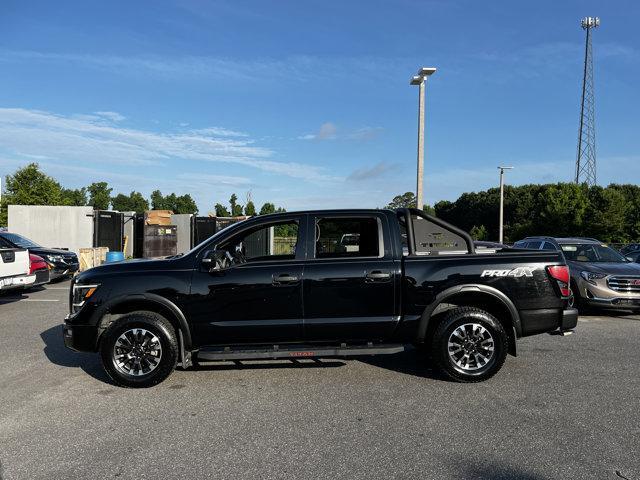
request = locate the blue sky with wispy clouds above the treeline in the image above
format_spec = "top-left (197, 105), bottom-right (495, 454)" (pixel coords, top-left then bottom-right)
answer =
top-left (0, 0), bottom-right (640, 214)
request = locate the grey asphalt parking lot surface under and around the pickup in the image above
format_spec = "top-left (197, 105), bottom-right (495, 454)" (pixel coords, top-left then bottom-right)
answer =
top-left (0, 282), bottom-right (640, 480)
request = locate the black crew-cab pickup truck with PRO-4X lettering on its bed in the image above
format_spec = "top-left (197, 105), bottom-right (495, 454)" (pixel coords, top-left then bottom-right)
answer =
top-left (63, 209), bottom-right (578, 387)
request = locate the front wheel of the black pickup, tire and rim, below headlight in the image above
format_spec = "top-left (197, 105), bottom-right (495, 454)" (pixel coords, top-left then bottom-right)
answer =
top-left (100, 312), bottom-right (178, 388)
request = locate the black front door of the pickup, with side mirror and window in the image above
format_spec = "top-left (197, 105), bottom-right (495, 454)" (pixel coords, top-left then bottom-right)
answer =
top-left (190, 215), bottom-right (306, 345)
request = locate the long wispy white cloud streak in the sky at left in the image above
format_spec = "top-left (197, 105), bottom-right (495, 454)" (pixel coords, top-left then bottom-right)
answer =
top-left (0, 108), bottom-right (336, 182)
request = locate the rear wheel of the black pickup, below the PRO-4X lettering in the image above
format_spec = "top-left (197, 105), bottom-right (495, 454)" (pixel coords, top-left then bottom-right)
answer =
top-left (431, 307), bottom-right (508, 383)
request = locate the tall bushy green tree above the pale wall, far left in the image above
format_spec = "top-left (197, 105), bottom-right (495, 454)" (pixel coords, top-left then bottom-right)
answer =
top-left (0, 163), bottom-right (62, 225)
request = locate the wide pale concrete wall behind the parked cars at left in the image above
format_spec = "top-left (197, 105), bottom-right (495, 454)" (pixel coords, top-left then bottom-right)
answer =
top-left (9, 205), bottom-right (93, 253)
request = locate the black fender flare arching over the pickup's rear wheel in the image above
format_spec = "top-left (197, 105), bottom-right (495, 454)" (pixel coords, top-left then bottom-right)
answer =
top-left (418, 284), bottom-right (522, 356)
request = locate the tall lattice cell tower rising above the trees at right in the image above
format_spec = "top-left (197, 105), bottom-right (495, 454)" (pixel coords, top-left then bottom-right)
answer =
top-left (575, 17), bottom-right (600, 186)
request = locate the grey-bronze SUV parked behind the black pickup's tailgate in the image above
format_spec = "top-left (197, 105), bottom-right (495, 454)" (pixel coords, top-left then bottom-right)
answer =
top-left (514, 237), bottom-right (640, 310)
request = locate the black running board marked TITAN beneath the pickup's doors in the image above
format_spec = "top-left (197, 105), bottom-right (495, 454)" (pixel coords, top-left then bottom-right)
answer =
top-left (196, 344), bottom-right (404, 360)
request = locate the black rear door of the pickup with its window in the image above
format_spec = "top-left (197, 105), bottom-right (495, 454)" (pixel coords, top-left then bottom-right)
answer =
top-left (303, 214), bottom-right (400, 342)
